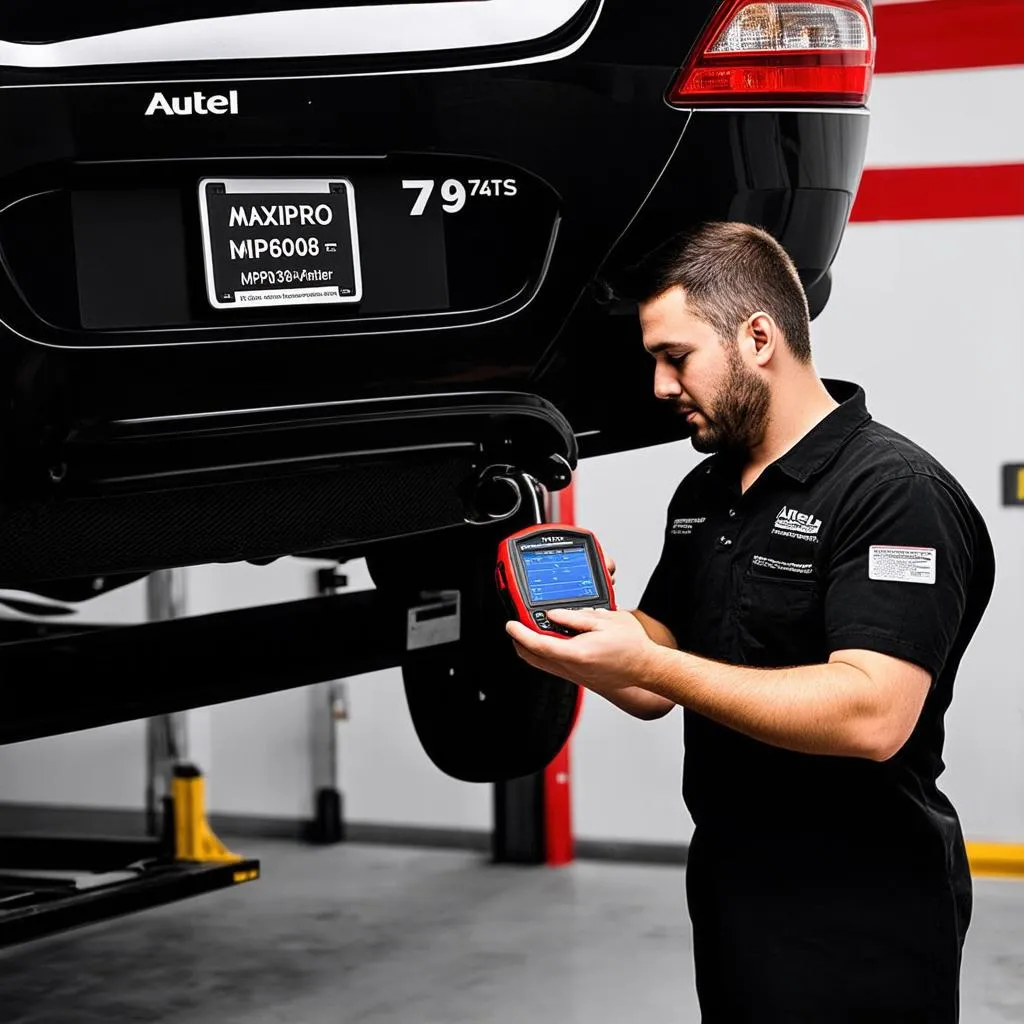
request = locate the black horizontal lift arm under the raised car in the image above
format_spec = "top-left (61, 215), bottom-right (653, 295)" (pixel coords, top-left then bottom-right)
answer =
top-left (0, 590), bottom-right (409, 743)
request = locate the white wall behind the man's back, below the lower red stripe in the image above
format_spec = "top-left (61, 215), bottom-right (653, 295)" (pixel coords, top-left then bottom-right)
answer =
top-left (815, 218), bottom-right (1024, 843)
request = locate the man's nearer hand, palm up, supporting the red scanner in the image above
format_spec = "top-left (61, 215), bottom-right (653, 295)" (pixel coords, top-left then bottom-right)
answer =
top-left (505, 608), bottom-right (658, 696)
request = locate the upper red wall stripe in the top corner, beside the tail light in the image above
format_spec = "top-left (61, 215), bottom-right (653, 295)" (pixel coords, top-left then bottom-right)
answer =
top-left (874, 0), bottom-right (1024, 75)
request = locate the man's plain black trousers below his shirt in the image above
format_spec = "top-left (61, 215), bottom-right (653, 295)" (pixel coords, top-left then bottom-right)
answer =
top-left (686, 829), bottom-right (971, 1024)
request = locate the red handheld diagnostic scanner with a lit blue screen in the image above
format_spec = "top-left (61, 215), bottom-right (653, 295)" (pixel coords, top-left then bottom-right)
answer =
top-left (495, 523), bottom-right (615, 637)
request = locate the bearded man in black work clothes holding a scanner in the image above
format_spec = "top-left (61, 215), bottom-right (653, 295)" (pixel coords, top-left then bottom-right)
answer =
top-left (508, 223), bottom-right (994, 1024)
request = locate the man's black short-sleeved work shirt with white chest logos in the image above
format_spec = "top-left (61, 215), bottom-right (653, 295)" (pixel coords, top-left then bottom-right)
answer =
top-left (639, 381), bottom-right (994, 870)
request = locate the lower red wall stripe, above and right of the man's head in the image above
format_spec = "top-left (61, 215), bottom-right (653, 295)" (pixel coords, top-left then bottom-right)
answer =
top-left (850, 164), bottom-right (1024, 222)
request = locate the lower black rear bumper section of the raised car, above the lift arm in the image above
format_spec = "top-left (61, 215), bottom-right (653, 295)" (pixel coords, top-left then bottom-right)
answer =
top-left (0, 392), bottom-right (577, 587)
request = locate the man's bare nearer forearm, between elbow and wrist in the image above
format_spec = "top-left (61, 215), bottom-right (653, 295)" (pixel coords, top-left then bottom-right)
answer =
top-left (638, 647), bottom-right (892, 760)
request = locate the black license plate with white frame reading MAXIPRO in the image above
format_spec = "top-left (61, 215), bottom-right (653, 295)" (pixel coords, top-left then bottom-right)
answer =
top-left (199, 178), bottom-right (362, 309)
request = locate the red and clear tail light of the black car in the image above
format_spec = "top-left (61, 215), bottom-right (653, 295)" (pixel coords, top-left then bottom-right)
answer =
top-left (668, 0), bottom-right (874, 106)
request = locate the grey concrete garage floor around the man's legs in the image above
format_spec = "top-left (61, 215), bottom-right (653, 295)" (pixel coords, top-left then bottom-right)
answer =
top-left (0, 841), bottom-right (1024, 1024)
